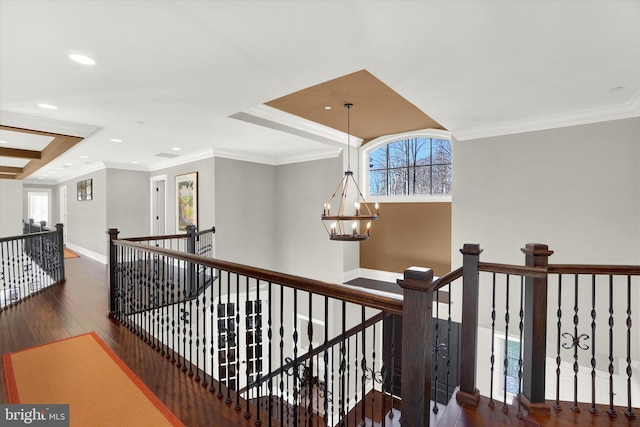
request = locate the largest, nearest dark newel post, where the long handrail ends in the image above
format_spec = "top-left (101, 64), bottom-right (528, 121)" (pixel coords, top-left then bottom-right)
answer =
top-left (397, 267), bottom-right (433, 426)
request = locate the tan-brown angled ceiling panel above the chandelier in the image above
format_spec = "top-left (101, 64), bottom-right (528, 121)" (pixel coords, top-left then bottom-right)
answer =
top-left (265, 70), bottom-right (446, 142)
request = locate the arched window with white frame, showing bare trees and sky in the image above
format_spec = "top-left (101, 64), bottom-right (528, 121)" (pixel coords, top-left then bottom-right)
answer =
top-left (360, 130), bottom-right (452, 201)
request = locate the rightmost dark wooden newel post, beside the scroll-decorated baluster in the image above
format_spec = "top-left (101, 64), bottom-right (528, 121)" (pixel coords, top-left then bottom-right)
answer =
top-left (522, 243), bottom-right (553, 412)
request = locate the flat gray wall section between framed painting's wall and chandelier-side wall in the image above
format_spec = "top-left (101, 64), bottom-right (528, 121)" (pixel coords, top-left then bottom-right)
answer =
top-left (215, 158), bottom-right (276, 270)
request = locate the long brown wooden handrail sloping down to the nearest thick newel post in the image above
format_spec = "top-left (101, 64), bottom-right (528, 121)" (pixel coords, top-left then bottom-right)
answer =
top-left (113, 240), bottom-right (403, 314)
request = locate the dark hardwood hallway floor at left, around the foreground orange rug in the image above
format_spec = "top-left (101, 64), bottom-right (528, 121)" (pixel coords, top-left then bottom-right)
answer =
top-left (0, 257), bottom-right (268, 427)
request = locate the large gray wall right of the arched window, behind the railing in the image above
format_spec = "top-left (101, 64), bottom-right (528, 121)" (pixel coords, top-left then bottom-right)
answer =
top-left (451, 118), bottom-right (640, 363)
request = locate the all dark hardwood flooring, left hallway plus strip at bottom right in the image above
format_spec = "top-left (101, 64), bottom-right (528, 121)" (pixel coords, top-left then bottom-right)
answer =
top-left (0, 257), bottom-right (640, 427)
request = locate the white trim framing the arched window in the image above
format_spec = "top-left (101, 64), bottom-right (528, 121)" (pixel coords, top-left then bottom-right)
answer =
top-left (358, 129), bottom-right (453, 203)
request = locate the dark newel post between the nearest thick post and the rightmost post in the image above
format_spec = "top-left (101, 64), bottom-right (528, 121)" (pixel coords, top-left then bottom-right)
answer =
top-left (456, 243), bottom-right (482, 405)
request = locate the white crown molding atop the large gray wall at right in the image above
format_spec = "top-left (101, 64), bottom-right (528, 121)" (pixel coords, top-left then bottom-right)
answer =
top-left (452, 91), bottom-right (640, 141)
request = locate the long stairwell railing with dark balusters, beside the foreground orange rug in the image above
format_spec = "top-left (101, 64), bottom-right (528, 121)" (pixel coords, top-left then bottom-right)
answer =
top-left (109, 230), bottom-right (416, 425)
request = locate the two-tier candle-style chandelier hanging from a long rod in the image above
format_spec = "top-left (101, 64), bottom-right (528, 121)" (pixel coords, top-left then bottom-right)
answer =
top-left (322, 104), bottom-right (379, 242)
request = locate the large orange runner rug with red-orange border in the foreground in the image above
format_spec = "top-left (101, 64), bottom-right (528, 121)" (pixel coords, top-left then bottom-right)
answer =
top-left (3, 332), bottom-right (183, 427)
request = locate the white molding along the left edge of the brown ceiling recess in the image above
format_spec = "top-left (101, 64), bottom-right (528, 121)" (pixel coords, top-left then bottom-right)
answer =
top-left (229, 104), bottom-right (363, 148)
